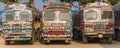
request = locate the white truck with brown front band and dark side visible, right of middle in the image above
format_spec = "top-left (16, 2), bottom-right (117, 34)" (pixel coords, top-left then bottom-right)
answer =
top-left (73, 2), bottom-right (114, 44)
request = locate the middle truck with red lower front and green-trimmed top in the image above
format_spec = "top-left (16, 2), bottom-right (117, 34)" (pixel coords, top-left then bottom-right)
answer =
top-left (40, 2), bottom-right (72, 43)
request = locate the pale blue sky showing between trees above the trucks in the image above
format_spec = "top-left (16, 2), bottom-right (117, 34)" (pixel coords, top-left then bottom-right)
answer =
top-left (0, 0), bottom-right (78, 11)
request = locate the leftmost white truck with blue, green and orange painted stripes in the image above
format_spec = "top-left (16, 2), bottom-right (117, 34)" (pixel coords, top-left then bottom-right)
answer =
top-left (2, 3), bottom-right (34, 44)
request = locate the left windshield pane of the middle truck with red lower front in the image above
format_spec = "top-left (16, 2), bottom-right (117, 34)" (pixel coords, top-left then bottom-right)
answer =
top-left (44, 11), bottom-right (55, 21)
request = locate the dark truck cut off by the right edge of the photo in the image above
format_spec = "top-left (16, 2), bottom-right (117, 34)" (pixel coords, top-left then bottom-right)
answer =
top-left (113, 4), bottom-right (120, 41)
